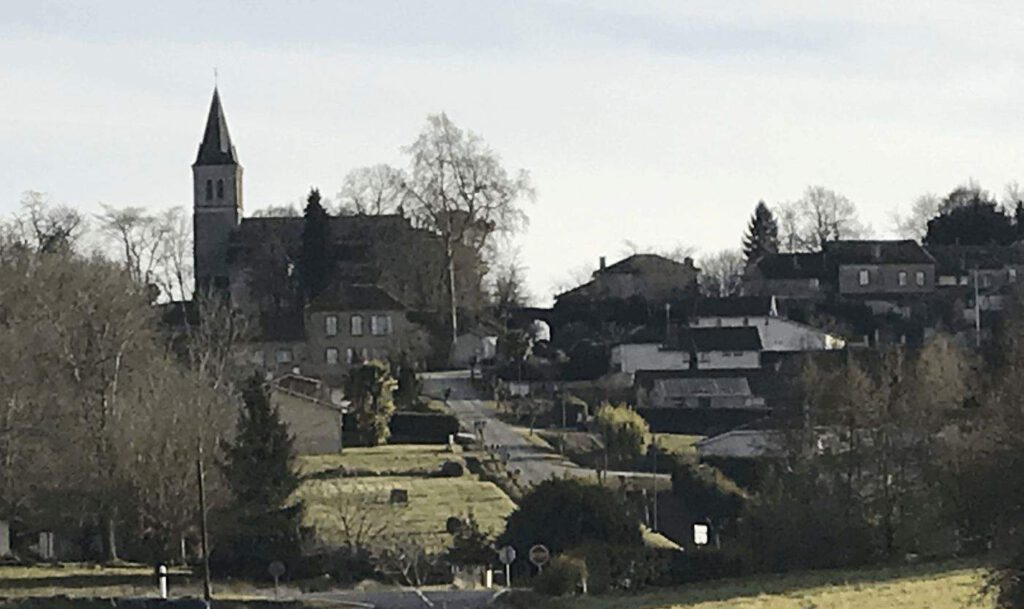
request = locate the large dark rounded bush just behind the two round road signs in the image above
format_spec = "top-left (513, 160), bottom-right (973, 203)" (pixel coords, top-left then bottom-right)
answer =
top-left (499, 480), bottom-right (640, 556)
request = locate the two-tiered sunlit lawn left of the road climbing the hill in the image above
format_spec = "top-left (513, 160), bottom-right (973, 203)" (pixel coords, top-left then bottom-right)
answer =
top-left (295, 445), bottom-right (515, 550)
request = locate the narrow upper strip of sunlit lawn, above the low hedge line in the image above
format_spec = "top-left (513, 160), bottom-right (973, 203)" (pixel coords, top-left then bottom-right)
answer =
top-left (296, 444), bottom-right (463, 476)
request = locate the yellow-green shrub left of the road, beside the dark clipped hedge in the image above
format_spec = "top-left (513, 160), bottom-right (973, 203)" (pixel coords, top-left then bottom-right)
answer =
top-left (345, 360), bottom-right (397, 446)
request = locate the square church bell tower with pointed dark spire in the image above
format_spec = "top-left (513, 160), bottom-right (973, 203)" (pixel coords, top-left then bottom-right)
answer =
top-left (193, 88), bottom-right (242, 292)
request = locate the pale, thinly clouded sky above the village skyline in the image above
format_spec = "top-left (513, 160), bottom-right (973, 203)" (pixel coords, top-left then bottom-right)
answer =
top-left (0, 0), bottom-right (1024, 304)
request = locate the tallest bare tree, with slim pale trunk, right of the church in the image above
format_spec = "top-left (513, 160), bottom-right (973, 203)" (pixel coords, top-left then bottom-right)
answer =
top-left (403, 114), bottom-right (532, 358)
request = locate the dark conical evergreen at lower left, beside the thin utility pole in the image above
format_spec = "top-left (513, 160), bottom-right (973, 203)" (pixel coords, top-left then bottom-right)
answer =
top-left (221, 375), bottom-right (302, 573)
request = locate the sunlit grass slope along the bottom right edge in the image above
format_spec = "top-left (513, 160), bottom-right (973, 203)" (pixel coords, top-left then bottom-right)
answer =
top-left (551, 563), bottom-right (994, 609)
